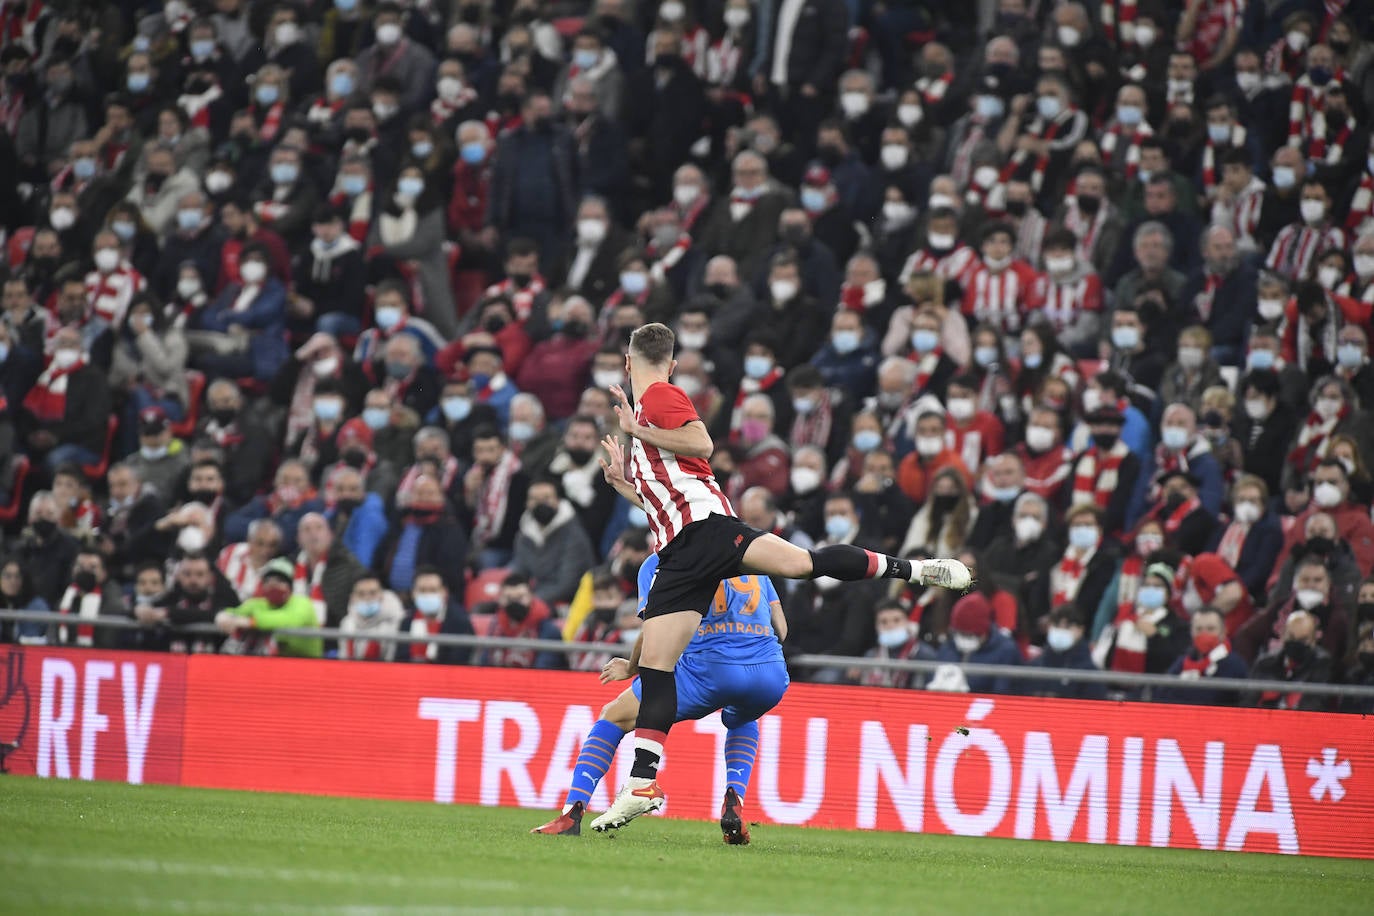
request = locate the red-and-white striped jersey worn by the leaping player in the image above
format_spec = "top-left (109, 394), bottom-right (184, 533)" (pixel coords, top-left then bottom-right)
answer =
top-left (629, 382), bottom-right (735, 551)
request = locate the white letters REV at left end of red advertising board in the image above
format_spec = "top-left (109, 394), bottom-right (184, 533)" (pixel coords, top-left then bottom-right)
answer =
top-left (36, 658), bottom-right (162, 784)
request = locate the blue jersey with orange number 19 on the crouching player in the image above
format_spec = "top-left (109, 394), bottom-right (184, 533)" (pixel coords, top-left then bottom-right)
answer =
top-left (639, 553), bottom-right (783, 665)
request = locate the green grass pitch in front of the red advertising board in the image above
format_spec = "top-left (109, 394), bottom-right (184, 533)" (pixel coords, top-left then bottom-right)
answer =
top-left (0, 776), bottom-right (1374, 916)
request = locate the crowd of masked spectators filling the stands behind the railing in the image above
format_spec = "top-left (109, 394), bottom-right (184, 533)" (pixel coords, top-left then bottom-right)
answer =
top-left (0, 0), bottom-right (1374, 711)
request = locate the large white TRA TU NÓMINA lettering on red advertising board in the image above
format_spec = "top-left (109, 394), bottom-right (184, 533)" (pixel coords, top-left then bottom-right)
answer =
top-left (419, 696), bottom-right (1300, 854)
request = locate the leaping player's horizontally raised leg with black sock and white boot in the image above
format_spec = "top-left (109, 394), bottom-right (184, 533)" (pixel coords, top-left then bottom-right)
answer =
top-left (741, 533), bottom-right (973, 591)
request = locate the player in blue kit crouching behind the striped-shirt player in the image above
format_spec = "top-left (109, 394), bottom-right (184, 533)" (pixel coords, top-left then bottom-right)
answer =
top-left (530, 555), bottom-right (787, 845)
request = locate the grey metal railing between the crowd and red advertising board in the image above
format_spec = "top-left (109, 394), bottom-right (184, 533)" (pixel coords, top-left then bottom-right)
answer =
top-left (0, 610), bottom-right (1374, 699)
